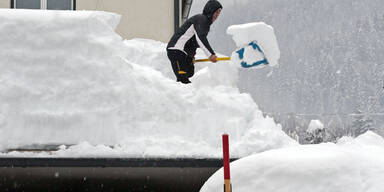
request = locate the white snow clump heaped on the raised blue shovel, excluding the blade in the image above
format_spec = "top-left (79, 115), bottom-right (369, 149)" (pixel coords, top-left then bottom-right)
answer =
top-left (227, 22), bottom-right (280, 67)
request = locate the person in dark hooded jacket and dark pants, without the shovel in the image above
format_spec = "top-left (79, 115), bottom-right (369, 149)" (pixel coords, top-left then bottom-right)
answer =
top-left (167, 0), bottom-right (223, 84)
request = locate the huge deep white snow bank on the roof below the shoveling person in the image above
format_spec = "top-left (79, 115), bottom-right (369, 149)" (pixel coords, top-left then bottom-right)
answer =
top-left (0, 9), bottom-right (297, 158)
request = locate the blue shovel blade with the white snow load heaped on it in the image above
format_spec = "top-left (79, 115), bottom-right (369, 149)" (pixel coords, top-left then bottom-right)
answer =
top-left (227, 22), bottom-right (280, 69)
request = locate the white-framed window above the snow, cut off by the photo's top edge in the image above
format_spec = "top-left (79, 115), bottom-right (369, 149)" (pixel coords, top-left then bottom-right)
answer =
top-left (11, 0), bottom-right (76, 10)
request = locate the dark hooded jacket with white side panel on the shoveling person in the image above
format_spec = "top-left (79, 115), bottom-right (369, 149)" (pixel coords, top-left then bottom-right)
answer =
top-left (167, 0), bottom-right (223, 57)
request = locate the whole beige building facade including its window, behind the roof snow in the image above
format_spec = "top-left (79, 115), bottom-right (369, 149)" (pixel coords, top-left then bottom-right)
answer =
top-left (0, 0), bottom-right (192, 42)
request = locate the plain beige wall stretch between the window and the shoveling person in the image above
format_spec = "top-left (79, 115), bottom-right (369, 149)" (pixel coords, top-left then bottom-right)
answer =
top-left (76, 0), bottom-right (177, 42)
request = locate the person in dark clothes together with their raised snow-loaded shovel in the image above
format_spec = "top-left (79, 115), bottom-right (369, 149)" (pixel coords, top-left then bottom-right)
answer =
top-left (167, 0), bottom-right (280, 84)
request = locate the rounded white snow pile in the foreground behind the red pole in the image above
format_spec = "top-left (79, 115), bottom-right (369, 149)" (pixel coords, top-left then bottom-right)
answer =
top-left (201, 132), bottom-right (384, 192)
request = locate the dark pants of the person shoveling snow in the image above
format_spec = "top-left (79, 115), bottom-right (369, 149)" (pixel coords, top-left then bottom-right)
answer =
top-left (167, 49), bottom-right (195, 83)
